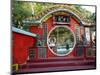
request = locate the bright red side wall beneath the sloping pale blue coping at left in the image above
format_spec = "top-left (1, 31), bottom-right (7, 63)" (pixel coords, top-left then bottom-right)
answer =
top-left (12, 32), bottom-right (36, 64)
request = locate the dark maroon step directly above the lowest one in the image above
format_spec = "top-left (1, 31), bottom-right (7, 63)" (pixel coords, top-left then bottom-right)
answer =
top-left (19, 60), bottom-right (95, 69)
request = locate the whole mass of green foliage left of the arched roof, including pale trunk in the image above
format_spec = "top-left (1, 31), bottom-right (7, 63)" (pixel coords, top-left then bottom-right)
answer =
top-left (12, 0), bottom-right (51, 30)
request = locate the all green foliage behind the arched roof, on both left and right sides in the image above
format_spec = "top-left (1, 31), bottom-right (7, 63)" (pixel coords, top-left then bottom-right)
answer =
top-left (12, 0), bottom-right (96, 29)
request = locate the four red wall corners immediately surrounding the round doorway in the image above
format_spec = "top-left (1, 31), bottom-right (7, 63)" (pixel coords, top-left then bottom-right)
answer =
top-left (46, 17), bottom-right (79, 58)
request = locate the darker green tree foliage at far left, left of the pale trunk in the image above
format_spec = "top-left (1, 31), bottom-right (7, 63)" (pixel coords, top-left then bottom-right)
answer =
top-left (12, 1), bottom-right (32, 25)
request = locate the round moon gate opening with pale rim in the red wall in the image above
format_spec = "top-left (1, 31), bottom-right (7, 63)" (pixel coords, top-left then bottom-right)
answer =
top-left (47, 26), bottom-right (76, 56)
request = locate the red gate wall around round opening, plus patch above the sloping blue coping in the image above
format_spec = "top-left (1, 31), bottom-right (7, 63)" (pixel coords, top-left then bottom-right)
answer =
top-left (30, 17), bottom-right (79, 58)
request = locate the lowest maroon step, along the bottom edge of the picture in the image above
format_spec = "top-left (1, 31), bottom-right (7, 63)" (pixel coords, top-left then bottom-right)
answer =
top-left (13, 65), bottom-right (96, 74)
